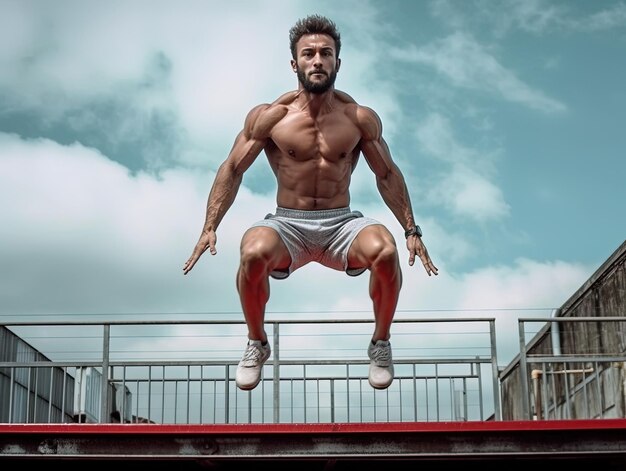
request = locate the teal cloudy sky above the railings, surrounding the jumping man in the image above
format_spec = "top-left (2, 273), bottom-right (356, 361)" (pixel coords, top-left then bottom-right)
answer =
top-left (0, 0), bottom-right (626, 366)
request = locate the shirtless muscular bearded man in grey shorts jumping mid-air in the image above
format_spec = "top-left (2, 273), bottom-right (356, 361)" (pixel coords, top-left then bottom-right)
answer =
top-left (183, 15), bottom-right (437, 390)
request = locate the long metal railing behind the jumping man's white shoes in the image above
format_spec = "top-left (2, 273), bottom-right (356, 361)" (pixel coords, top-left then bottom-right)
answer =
top-left (0, 318), bottom-right (500, 424)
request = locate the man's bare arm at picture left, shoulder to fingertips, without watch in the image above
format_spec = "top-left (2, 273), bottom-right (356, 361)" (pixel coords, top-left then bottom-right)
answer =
top-left (183, 105), bottom-right (269, 275)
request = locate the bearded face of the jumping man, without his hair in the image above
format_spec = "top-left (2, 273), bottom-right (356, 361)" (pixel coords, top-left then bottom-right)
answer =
top-left (291, 34), bottom-right (340, 93)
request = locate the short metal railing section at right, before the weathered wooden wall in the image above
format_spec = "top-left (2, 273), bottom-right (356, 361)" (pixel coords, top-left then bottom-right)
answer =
top-left (518, 317), bottom-right (626, 420)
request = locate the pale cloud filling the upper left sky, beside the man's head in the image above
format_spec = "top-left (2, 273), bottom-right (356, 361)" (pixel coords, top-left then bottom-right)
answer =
top-left (0, 0), bottom-right (298, 163)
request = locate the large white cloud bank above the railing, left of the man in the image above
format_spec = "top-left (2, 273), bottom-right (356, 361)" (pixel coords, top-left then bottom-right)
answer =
top-left (0, 135), bottom-right (244, 313)
